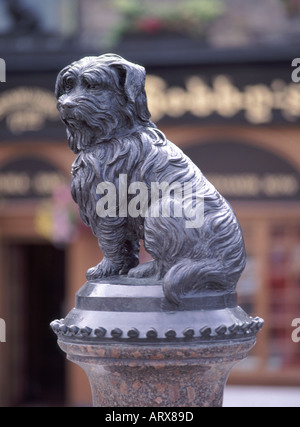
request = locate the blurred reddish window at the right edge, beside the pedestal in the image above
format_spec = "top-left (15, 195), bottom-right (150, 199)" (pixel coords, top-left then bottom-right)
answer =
top-left (269, 223), bottom-right (300, 369)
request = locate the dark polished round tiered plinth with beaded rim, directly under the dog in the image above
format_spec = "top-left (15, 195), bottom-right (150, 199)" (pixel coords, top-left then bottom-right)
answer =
top-left (51, 276), bottom-right (263, 342)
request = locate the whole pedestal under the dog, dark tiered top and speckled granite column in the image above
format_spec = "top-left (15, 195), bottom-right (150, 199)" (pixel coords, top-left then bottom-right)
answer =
top-left (51, 277), bottom-right (263, 407)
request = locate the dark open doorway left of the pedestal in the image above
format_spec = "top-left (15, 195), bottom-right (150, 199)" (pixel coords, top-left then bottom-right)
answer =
top-left (4, 242), bottom-right (65, 405)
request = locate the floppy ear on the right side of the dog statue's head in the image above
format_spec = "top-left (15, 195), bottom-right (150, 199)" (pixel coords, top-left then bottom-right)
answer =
top-left (112, 60), bottom-right (146, 103)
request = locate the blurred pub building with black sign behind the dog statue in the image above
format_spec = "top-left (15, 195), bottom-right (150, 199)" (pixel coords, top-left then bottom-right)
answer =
top-left (0, 0), bottom-right (300, 406)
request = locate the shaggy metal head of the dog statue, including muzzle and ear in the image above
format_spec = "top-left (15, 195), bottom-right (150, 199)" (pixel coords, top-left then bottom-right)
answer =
top-left (55, 54), bottom-right (150, 153)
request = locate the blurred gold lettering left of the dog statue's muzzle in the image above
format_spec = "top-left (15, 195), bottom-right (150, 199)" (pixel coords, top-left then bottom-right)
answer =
top-left (0, 87), bottom-right (59, 134)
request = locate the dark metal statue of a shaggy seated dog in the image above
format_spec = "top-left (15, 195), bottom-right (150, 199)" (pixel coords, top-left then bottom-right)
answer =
top-left (56, 54), bottom-right (245, 304)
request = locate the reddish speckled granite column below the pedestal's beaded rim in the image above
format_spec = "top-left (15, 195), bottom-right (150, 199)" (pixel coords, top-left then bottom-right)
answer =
top-left (58, 338), bottom-right (255, 407)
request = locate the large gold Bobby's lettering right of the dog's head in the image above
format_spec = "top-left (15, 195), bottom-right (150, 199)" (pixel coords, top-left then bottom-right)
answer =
top-left (146, 75), bottom-right (300, 124)
